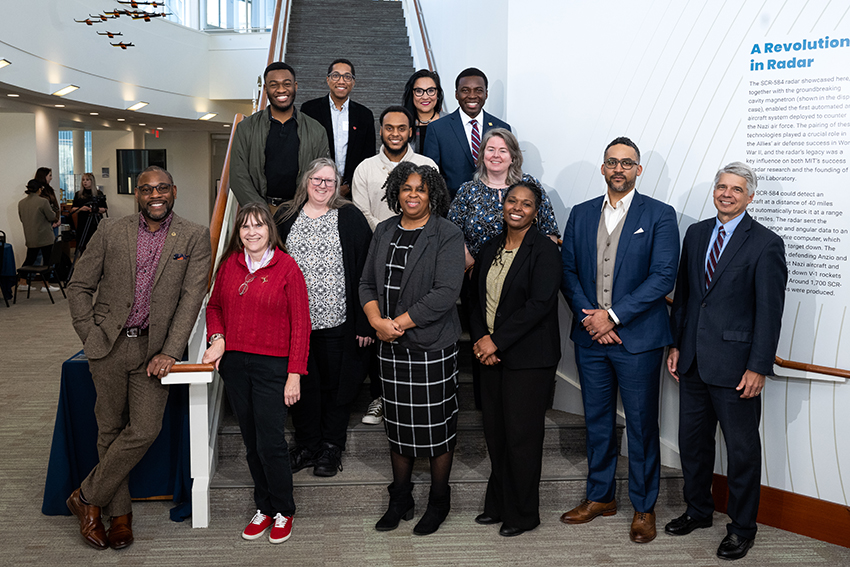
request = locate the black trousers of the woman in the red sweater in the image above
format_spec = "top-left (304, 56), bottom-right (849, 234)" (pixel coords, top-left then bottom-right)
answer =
top-left (219, 351), bottom-right (294, 516)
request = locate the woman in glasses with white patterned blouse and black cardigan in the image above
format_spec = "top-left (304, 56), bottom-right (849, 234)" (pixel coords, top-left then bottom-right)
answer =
top-left (275, 158), bottom-right (375, 476)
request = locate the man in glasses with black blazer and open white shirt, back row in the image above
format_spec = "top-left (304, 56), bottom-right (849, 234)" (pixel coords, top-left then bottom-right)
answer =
top-left (301, 59), bottom-right (377, 199)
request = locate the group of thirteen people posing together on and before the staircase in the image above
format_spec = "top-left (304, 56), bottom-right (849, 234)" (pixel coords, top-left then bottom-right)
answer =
top-left (59, 59), bottom-right (787, 559)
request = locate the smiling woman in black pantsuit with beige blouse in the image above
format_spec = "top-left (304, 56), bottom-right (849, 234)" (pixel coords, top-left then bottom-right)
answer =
top-left (470, 181), bottom-right (561, 536)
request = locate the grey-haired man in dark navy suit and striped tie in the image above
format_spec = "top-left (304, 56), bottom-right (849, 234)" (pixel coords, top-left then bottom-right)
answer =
top-left (664, 162), bottom-right (788, 559)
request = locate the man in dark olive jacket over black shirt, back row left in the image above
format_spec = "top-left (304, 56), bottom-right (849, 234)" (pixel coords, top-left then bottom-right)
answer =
top-left (230, 61), bottom-right (329, 213)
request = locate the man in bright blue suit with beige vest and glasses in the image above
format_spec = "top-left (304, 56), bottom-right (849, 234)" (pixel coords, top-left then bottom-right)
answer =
top-left (561, 137), bottom-right (679, 543)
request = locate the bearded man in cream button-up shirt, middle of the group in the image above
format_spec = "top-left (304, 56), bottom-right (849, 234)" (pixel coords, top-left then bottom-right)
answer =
top-left (351, 106), bottom-right (437, 231)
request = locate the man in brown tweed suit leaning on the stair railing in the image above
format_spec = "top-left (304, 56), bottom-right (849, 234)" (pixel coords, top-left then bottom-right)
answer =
top-left (67, 166), bottom-right (210, 549)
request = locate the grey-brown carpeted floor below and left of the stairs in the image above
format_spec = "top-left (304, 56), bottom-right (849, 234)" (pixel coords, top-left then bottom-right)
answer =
top-left (0, 293), bottom-right (850, 567)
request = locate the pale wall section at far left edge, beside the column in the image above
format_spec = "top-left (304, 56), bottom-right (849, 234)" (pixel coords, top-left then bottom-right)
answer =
top-left (0, 116), bottom-right (38, 266)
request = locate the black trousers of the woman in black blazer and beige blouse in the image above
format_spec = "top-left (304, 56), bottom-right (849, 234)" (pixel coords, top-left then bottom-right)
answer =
top-left (475, 362), bottom-right (555, 530)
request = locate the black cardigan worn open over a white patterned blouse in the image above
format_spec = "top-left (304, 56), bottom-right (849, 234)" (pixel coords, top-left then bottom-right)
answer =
top-left (275, 204), bottom-right (375, 403)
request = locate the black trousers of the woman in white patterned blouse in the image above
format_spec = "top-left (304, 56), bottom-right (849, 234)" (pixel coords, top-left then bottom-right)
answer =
top-left (291, 325), bottom-right (348, 452)
